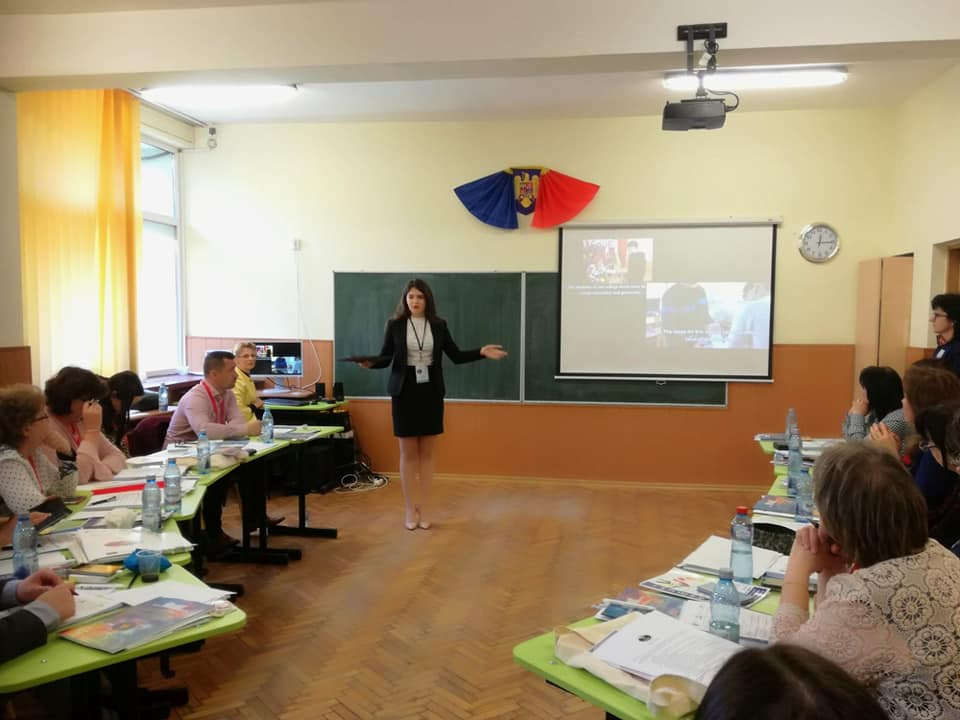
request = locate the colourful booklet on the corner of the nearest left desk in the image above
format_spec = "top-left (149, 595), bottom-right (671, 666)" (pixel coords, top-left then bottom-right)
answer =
top-left (60, 597), bottom-right (213, 653)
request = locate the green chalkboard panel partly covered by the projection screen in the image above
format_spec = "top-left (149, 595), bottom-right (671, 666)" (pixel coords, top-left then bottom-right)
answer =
top-left (523, 273), bottom-right (727, 406)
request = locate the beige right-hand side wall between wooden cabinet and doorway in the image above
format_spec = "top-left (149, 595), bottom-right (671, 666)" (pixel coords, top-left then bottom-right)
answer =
top-left (891, 65), bottom-right (960, 347)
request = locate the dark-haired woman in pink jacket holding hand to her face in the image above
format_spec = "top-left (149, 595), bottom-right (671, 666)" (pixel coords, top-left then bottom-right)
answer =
top-left (43, 366), bottom-right (127, 484)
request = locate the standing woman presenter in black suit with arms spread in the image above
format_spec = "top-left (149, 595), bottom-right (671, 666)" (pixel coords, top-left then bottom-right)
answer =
top-left (359, 279), bottom-right (507, 530)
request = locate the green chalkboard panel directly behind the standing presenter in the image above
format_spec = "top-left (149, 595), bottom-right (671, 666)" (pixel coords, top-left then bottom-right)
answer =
top-left (333, 273), bottom-right (523, 401)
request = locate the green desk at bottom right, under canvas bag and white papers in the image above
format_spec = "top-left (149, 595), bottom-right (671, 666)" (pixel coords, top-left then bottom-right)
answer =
top-left (513, 591), bottom-right (780, 720)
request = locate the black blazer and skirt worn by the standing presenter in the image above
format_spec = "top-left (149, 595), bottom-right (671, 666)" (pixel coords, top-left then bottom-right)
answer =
top-left (372, 318), bottom-right (483, 437)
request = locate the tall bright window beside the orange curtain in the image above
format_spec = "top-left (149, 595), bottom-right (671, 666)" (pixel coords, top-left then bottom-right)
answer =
top-left (137, 143), bottom-right (184, 375)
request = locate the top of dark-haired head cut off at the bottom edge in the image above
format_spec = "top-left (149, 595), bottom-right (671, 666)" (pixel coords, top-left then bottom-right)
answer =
top-left (694, 643), bottom-right (887, 720)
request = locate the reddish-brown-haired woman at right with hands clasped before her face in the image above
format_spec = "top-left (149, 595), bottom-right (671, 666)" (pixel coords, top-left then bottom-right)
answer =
top-left (870, 360), bottom-right (960, 508)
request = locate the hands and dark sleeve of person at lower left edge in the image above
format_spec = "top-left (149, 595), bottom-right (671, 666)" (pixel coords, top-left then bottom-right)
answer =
top-left (0, 568), bottom-right (76, 662)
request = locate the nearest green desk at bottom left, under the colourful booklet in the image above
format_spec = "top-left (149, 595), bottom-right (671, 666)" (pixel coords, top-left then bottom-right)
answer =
top-left (0, 565), bottom-right (247, 718)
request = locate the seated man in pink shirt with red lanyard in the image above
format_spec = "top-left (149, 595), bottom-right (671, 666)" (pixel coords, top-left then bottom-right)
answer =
top-left (163, 350), bottom-right (260, 555)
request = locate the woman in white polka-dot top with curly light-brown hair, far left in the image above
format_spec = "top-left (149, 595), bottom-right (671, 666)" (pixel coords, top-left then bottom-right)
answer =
top-left (0, 385), bottom-right (77, 516)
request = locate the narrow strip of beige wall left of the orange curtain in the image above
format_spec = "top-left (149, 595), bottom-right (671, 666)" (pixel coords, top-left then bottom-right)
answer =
top-left (0, 91), bottom-right (23, 347)
